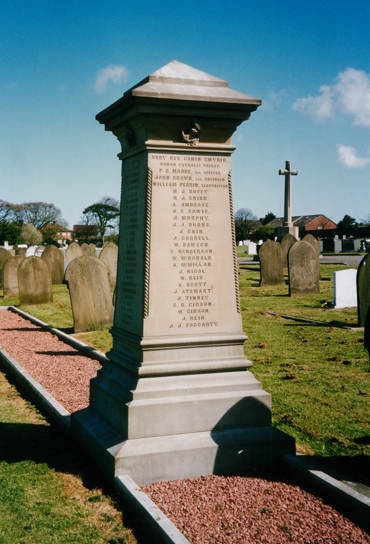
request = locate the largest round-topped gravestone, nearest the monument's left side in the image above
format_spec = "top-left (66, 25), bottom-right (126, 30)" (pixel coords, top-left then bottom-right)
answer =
top-left (65, 256), bottom-right (113, 332)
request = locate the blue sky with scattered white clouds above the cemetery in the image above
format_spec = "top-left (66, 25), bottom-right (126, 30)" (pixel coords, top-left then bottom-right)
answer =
top-left (0, 0), bottom-right (370, 228)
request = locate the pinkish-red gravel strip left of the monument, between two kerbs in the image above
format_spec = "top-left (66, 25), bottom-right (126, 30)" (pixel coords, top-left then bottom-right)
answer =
top-left (0, 310), bottom-right (101, 412)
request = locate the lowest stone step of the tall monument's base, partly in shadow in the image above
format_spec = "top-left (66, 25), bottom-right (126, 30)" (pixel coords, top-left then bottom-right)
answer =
top-left (72, 408), bottom-right (295, 485)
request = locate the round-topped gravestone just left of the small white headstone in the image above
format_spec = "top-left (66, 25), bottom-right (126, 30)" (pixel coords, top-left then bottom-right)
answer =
top-left (288, 241), bottom-right (320, 297)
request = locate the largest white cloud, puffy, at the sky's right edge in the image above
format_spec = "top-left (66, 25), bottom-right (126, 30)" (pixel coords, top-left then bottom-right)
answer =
top-left (292, 68), bottom-right (370, 128)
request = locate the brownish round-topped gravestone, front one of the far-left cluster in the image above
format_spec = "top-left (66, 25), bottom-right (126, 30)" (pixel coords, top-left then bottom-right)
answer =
top-left (18, 257), bottom-right (53, 306)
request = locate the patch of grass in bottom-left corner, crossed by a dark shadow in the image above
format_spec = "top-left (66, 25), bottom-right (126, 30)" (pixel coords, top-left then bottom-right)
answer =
top-left (0, 372), bottom-right (137, 544)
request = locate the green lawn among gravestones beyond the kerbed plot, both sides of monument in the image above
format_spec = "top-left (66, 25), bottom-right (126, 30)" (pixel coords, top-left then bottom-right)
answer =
top-left (0, 264), bottom-right (370, 462)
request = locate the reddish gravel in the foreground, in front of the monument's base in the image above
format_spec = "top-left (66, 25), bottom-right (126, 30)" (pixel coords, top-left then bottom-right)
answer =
top-left (142, 476), bottom-right (370, 544)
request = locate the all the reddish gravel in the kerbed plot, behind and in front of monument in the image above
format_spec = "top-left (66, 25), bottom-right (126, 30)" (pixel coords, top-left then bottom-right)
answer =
top-left (0, 310), bottom-right (370, 544)
